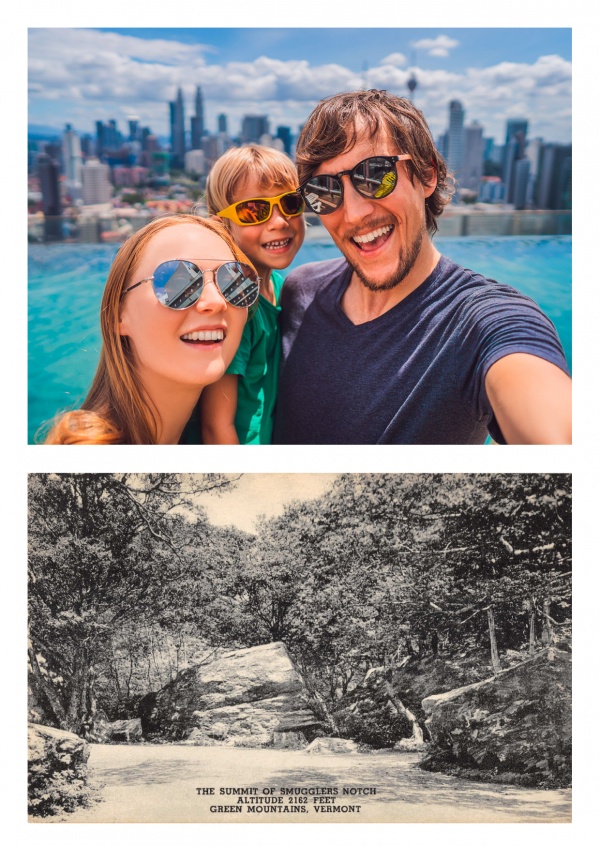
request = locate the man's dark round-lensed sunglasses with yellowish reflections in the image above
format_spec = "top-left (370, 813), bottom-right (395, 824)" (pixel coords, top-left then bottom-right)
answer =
top-left (298, 153), bottom-right (412, 214)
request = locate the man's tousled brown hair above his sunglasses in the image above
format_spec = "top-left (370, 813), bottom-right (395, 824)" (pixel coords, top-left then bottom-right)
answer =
top-left (296, 89), bottom-right (454, 235)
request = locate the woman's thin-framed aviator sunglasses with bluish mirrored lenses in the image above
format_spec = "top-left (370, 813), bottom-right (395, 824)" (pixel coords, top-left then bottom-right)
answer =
top-left (121, 259), bottom-right (260, 309)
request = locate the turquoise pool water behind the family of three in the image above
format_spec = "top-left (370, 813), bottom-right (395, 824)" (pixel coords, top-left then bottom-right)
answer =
top-left (28, 236), bottom-right (572, 443)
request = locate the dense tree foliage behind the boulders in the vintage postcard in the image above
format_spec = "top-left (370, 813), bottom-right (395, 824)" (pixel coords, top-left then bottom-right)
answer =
top-left (29, 474), bottom-right (571, 731)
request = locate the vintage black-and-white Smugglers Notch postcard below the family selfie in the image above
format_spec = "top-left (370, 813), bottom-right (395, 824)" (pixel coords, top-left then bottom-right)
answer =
top-left (29, 473), bottom-right (571, 823)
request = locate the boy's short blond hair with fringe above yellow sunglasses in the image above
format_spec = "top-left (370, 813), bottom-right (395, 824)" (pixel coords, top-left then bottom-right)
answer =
top-left (206, 144), bottom-right (298, 217)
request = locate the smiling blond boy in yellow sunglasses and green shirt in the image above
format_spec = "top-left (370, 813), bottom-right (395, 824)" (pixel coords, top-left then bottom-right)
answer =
top-left (201, 145), bottom-right (305, 444)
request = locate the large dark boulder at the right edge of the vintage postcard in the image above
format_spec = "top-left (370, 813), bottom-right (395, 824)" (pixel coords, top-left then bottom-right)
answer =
top-left (422, 648), bottom-right (571, 787)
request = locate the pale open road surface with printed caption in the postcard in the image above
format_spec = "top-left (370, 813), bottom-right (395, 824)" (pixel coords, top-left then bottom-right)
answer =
top-left (56, 744), bottom-right (571, 823)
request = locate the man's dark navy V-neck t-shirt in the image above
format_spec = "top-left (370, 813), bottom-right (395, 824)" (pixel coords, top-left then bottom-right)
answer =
top-left (273, 256), bottom-right (568, 444)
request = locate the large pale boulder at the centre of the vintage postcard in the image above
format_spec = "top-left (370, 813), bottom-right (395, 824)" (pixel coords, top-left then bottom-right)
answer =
top-left (140, 643), bottom-right (321, 746)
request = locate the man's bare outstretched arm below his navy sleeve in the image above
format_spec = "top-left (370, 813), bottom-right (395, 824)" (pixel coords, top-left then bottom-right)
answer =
top-left (485, 353), bottom-right (571, 444)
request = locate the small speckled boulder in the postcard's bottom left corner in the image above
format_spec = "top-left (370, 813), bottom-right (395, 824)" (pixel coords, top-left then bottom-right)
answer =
top-left (27, 723), bottom-right (90, 817)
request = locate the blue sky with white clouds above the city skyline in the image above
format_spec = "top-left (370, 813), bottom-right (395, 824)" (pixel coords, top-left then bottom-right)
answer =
top-left (28, 27), bottom-right (572, 142)
